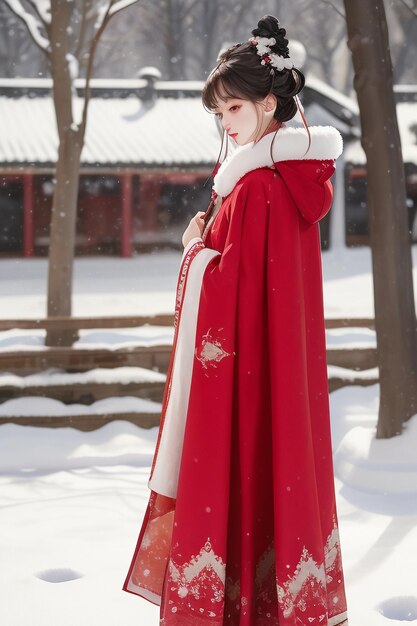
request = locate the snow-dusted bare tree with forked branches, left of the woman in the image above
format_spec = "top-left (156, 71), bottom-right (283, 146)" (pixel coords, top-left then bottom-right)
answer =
top-left (5, 0), bottom-right (138, 346)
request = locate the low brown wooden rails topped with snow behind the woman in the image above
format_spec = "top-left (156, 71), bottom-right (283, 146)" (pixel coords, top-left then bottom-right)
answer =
top-left (0, 315), bottom-right (378, 430)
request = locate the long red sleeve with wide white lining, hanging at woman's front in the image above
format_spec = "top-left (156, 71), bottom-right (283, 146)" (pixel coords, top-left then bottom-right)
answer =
top-left (148, 172), bottom-right (269, 497)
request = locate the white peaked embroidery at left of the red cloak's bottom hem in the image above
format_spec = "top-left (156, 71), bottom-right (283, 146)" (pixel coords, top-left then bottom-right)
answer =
top-left (168, 538), bottom-right (226, 617)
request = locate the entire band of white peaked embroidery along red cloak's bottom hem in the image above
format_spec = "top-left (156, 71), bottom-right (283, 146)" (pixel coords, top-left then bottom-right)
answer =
top-left (161, 523), bottom-right (348, 626)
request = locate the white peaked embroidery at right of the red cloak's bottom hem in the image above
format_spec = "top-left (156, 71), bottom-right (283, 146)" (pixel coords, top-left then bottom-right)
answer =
top-left (277, 522), bottom-right (346, 626)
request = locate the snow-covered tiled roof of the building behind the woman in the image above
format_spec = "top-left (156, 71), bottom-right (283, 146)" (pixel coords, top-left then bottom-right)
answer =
top-left (0, 75), bottom-right (417, 168)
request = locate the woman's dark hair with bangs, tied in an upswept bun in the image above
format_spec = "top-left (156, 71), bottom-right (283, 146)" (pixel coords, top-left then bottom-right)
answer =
top-left (202, 15), bottom-right (305, 130)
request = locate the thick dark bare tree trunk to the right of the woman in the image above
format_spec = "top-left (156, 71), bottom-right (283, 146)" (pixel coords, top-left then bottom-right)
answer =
top-left (345, 0), bottom-right (417, 438)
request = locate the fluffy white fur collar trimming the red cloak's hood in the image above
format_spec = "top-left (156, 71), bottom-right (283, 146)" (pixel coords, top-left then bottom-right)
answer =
top-left (213, 124), bottom-right (343, 198)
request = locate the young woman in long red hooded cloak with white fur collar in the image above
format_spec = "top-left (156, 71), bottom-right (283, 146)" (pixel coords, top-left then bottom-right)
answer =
top-left (123, 16), bottom-right (347, 626)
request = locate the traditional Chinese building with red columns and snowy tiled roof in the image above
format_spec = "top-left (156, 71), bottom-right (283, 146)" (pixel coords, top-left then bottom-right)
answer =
top-left (0, 73), bottom-right (376, 256)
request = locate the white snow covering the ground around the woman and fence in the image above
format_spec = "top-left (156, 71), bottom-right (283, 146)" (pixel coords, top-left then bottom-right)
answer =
top-left (0, 246), bottom-right (417, 626)
